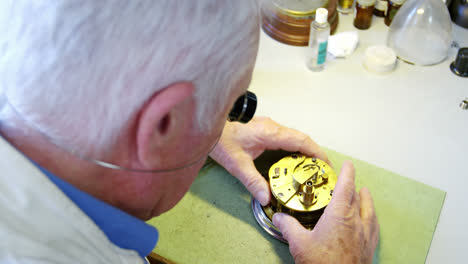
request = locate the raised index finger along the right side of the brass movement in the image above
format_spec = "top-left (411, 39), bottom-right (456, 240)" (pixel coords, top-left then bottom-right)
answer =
top-left (330, 161), bottom-right (356, 205)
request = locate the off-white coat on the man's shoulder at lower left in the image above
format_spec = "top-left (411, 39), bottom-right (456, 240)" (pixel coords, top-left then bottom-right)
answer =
top-left (0, 137), bottom-right (145, 264)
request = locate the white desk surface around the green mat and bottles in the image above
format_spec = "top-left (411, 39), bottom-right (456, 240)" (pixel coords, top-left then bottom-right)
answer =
top-left (250, 12), bottom-right (468, 263)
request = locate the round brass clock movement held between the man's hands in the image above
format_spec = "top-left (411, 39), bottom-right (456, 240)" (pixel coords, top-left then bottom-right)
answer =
top-left (252, 153), bottom-right (337, 242)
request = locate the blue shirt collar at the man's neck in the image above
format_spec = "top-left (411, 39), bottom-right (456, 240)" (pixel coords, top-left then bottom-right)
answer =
top-left (33, 162), bottom-right (159, 257)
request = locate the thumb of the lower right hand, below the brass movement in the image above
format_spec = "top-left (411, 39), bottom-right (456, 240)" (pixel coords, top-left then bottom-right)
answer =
top-left (273, 213), bottom-right (309, 243)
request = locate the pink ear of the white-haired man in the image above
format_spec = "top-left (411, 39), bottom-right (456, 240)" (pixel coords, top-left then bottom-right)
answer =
top-left (136, 82), bottom-right (195, 168)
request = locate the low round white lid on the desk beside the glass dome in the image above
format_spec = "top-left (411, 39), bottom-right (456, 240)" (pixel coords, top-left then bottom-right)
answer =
top-left (362, 45), bottom-right (396, 73)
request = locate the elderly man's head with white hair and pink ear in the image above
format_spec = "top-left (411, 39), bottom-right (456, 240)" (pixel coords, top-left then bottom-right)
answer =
top-left (0, 0), bottom-right (258, 219)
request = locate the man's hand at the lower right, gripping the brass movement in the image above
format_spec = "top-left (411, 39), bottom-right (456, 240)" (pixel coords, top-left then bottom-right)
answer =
top-left (273, 162), bottom-right (379, 264)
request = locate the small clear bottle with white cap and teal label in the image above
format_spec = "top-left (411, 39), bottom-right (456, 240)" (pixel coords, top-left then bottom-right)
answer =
top-left (307, 8), bottom-right (330, 71)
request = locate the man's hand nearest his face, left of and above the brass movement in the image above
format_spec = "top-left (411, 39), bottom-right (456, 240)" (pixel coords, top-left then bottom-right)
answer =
top-left (210, 117), bottom-right (331, 205)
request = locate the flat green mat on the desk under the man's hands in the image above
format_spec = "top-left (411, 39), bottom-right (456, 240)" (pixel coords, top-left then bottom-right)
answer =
top-left (148, 150), bottom-right (445, 264)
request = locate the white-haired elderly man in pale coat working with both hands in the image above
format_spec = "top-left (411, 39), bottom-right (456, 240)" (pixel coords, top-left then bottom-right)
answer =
top-left (0, 0), bottom-right (378, 263)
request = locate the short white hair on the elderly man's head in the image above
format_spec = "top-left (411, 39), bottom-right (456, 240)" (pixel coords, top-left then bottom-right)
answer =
top-left (0, 0), bottom-right (258, 155)
